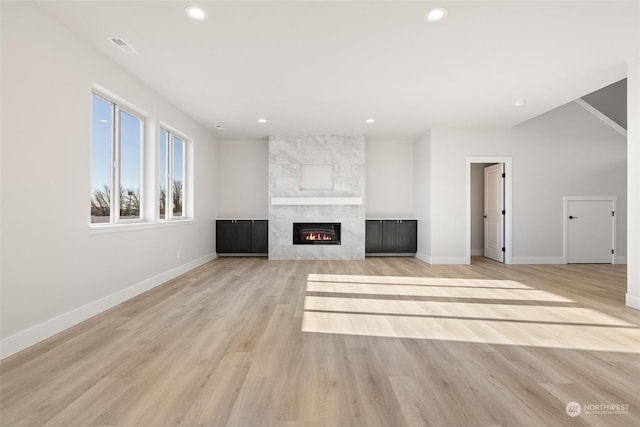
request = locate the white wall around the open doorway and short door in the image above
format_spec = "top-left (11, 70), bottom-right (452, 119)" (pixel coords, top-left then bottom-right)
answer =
top-left (430, 103), bottom-right (626, 263)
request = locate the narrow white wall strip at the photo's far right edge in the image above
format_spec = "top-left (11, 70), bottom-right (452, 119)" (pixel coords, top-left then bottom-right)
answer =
top-left (626, 58), bottom-right (640, 310)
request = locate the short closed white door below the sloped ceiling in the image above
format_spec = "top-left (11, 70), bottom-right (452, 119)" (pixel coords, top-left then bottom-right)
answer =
top-left (565, 199), bottom-right (616, 264)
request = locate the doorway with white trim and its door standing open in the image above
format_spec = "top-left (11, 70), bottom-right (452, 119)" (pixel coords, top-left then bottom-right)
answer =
top-left (466, 156), bottom-right (512, 264)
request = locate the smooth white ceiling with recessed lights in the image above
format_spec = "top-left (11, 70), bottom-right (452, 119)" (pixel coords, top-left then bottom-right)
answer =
top-left (36, 0), bottom-right (640, 139)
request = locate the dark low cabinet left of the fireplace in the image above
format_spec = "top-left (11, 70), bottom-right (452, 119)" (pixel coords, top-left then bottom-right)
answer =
top-left (216, 219), bottom-right (268, 254)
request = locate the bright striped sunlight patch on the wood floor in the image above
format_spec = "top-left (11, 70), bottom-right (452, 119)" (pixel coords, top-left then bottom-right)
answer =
top-left (302, 274), bottom-right (640, 353)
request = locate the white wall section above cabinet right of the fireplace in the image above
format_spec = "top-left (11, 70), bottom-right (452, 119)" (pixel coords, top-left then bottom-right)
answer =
top-left (366, 140), bottom-right (414, 218)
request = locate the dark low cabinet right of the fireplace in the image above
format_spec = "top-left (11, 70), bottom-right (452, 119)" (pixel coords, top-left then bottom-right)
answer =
top-left (365, 219), bottom-right (418, 254)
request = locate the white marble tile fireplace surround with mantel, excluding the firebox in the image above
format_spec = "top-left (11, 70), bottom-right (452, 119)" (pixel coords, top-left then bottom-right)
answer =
top-left (269, 135), bottom-right (366, 260)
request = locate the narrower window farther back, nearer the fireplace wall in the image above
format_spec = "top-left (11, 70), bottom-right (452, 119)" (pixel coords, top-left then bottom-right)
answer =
top-left (158, 128), bottom-right (186, 220)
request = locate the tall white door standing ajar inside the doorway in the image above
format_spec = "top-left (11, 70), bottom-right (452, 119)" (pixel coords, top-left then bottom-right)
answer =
top-left (484, 163), bottom-right (504, 262)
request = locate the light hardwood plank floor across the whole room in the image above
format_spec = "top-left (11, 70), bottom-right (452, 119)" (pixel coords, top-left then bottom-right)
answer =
top-left (0, 258), bottom-right (640, 427)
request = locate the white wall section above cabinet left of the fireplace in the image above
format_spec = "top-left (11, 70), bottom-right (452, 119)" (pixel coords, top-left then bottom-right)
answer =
top-left (217, 140), bottom-right (269, 219)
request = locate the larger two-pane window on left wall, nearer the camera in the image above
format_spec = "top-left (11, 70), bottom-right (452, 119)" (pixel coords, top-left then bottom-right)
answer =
top-left (91, 93), bottom-right (144, 224)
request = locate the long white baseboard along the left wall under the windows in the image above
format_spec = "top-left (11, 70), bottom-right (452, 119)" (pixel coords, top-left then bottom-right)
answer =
top-left (0, 253), bottom-right (217, 359)
